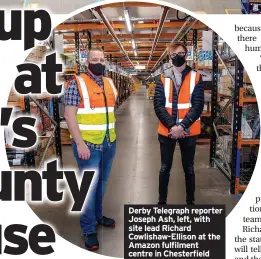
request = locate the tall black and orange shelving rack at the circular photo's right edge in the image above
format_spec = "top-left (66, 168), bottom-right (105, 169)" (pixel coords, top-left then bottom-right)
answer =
top-left (210, 32), bottom-right (259, 194)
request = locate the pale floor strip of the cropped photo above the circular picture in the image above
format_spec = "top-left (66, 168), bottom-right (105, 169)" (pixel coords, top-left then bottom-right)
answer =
top-left (1, 0), bottom-right (241, 14)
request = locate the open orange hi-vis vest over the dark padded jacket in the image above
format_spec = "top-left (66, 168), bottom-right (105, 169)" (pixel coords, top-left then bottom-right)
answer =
top-left (158, 70), bottom-right (201, 137)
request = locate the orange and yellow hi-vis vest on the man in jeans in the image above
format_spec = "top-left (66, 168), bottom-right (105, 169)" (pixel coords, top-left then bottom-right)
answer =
top-left (65, 74), bottom-right (118, 144)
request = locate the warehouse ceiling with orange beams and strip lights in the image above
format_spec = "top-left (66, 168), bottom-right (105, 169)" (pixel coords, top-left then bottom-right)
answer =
top-left (56, 2), bottom-right (207, 75)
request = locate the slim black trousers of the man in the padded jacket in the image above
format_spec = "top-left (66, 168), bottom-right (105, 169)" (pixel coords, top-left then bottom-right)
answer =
top-left (159, 135), bottom-right (197, 202)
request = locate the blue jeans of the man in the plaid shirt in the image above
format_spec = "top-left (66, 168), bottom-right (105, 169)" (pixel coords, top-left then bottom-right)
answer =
top-left (72, 140), bottom-right (116, 235)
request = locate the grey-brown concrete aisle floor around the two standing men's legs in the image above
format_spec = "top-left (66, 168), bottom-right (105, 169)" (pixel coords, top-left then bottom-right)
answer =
top-left (31, 87), bottom-right (237, 257)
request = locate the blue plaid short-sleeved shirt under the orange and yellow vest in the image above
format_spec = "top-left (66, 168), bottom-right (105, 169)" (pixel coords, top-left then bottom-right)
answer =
top-left (63, 70), bottom-right (111, 151)
